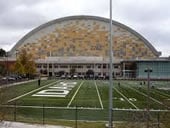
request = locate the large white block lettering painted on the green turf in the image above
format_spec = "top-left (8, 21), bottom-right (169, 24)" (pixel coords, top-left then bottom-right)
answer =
top-left (32, 82), bottom-right (77, 97)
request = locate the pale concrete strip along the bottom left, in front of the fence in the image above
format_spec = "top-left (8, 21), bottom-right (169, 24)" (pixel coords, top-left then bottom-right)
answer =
top-left (0, 121), bottom-right (71, 128)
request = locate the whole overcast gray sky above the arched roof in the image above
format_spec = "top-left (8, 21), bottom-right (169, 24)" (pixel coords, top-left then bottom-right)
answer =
top-left (0, 0), bottom-right (170, 56)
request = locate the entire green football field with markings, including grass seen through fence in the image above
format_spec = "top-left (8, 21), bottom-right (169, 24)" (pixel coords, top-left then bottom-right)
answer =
top-left (1, 79), bottom-right (170, 122)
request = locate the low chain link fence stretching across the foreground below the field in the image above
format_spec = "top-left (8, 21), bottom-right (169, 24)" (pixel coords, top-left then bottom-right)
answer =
top-left (0, 105), bottom-right (170, 128)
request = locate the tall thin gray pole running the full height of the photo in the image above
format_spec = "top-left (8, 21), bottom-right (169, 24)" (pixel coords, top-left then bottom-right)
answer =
top-left (109, 0), bottom-right (113, 128)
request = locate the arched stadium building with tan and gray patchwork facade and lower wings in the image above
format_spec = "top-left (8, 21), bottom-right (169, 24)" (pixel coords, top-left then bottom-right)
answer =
top-left (6, 16), bottom-right (170, 78)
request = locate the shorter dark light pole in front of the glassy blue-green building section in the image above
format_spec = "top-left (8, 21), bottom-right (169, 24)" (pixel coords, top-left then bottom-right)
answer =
top-left (145, 68), bottom-right (152, 128)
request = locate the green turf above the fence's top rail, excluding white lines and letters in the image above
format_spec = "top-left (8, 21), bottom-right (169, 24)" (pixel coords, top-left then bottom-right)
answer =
top-left (2, 80), bottom-right (170, 109)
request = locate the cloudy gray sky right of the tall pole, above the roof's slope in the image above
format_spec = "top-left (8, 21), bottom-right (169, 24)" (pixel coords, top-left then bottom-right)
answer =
top-left (113, 0), bottom-right (170, 56)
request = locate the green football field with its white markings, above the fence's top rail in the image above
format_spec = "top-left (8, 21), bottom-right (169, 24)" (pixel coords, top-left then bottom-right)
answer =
top-left (7, 80), bottom-right (170, 110)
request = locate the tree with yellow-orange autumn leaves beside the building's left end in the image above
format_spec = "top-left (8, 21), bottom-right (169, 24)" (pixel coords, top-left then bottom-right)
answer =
top-left (15, 49), bottom-right (36, 77)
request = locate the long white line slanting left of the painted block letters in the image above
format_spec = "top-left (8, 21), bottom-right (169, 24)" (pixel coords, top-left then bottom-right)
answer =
top-left (7, 81), bottom-right (59, 103)
